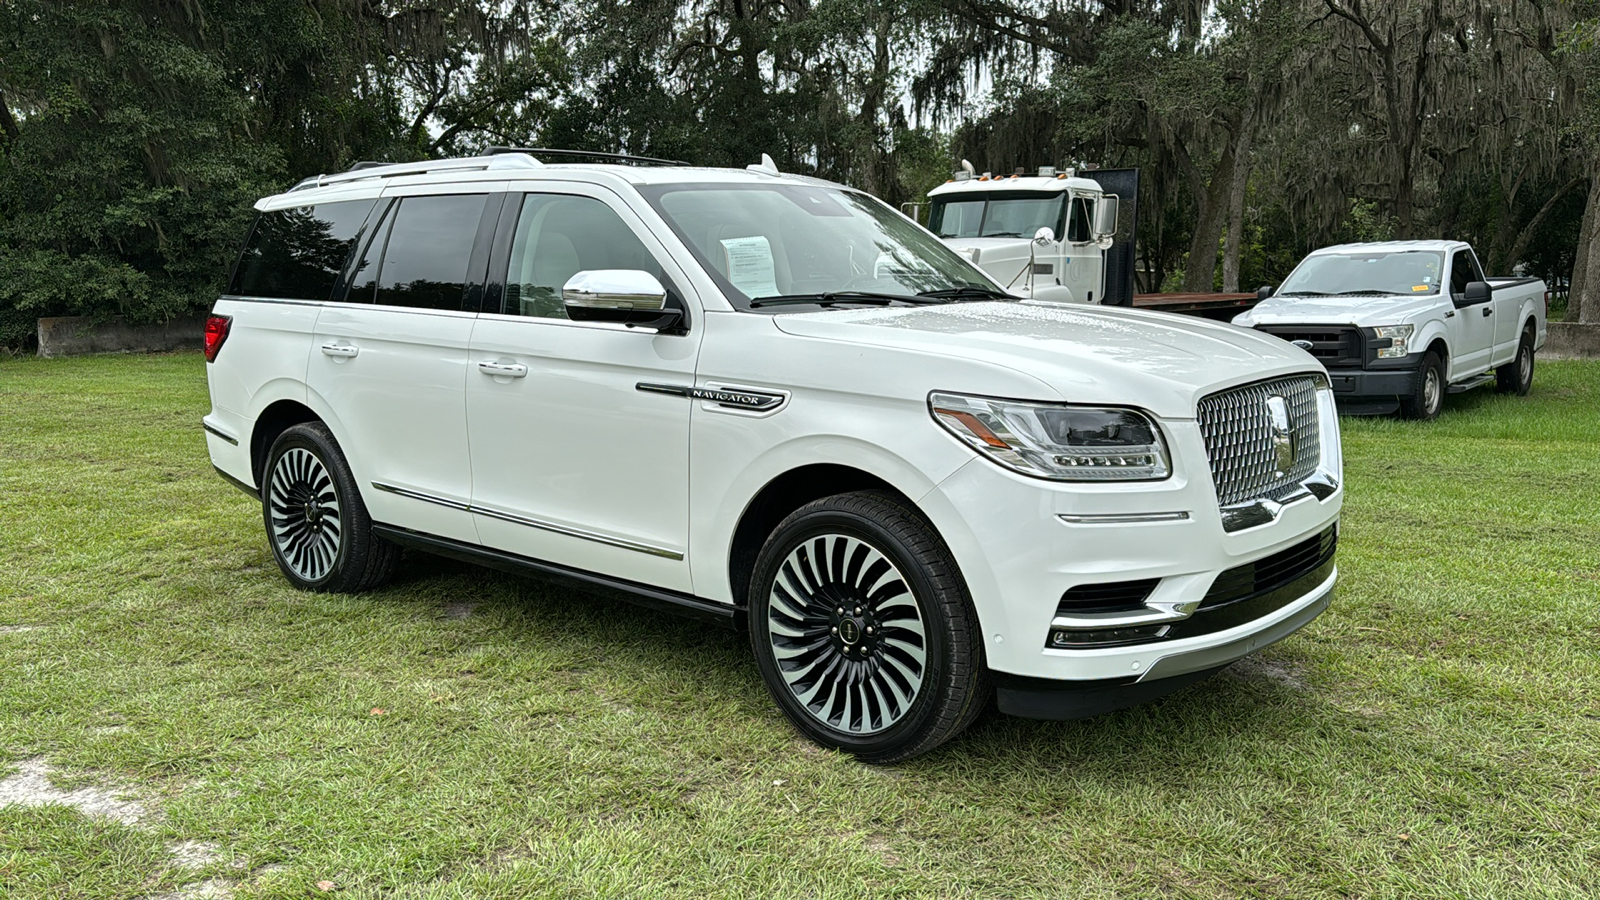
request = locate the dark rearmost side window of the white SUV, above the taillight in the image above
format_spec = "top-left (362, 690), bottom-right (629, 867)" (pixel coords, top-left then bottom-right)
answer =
top-left (227, 200), bottom-right (376, 299)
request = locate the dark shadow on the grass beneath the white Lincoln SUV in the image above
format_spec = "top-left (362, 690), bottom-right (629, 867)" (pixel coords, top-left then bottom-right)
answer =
top-left (368, 551), bottom-right (1331, 778)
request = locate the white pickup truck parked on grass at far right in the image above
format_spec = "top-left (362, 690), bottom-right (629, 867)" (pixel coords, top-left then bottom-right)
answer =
top-left (1234, 240), bottom-right (1546, 420)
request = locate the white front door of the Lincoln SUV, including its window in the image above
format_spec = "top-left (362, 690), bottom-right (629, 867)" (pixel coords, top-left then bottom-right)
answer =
top-left (466, 184), bottom-right (704, 591)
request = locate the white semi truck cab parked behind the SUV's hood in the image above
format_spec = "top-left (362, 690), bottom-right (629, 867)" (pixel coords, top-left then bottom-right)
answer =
top-left (928, 160), bottom-right (1120, 303)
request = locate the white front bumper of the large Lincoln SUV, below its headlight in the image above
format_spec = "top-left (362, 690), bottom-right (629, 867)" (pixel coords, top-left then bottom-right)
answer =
top-left (918, 400), bottom-right (1344, 685)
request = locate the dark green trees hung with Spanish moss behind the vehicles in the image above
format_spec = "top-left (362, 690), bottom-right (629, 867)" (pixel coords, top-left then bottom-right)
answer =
top-left (0, 0), bottom-right (1600, 348)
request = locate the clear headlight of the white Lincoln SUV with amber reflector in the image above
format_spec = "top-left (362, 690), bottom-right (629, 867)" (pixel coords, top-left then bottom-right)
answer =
top-left (928, 394), bottom-right (1173, 482)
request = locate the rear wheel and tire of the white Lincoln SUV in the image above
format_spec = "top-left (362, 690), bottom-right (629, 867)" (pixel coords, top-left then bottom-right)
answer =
top-left (261, 421), bottom-right (400, 594)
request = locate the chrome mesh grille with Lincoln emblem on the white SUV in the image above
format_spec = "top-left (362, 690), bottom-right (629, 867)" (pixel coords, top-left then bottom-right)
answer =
top-left (1200, 375), bottom-right (1322, 506)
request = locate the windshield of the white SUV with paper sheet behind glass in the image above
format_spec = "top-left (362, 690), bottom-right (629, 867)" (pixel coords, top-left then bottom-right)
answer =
top-left (638, 184), bottom-right (1005, 309)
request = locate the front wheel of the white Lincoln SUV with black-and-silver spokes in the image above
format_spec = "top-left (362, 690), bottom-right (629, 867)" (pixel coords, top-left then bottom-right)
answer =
top-left (747, 492), bottom-right (992, 764)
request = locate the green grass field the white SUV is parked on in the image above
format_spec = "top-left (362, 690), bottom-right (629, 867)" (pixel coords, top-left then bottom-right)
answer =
top-left (0, 354), bottom-right (1600, 898)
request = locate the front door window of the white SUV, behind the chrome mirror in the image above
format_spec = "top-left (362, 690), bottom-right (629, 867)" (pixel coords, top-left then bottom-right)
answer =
top-left (506, 194), bottom-right (666, 319)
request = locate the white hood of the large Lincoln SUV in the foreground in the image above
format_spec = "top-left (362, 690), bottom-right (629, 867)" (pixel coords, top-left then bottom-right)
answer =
top-left (773, 301), bottom-right (1322, 418)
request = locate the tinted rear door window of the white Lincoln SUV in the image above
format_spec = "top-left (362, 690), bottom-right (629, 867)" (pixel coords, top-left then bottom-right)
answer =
top-left (369, 194), bottom-right (486, 309)
